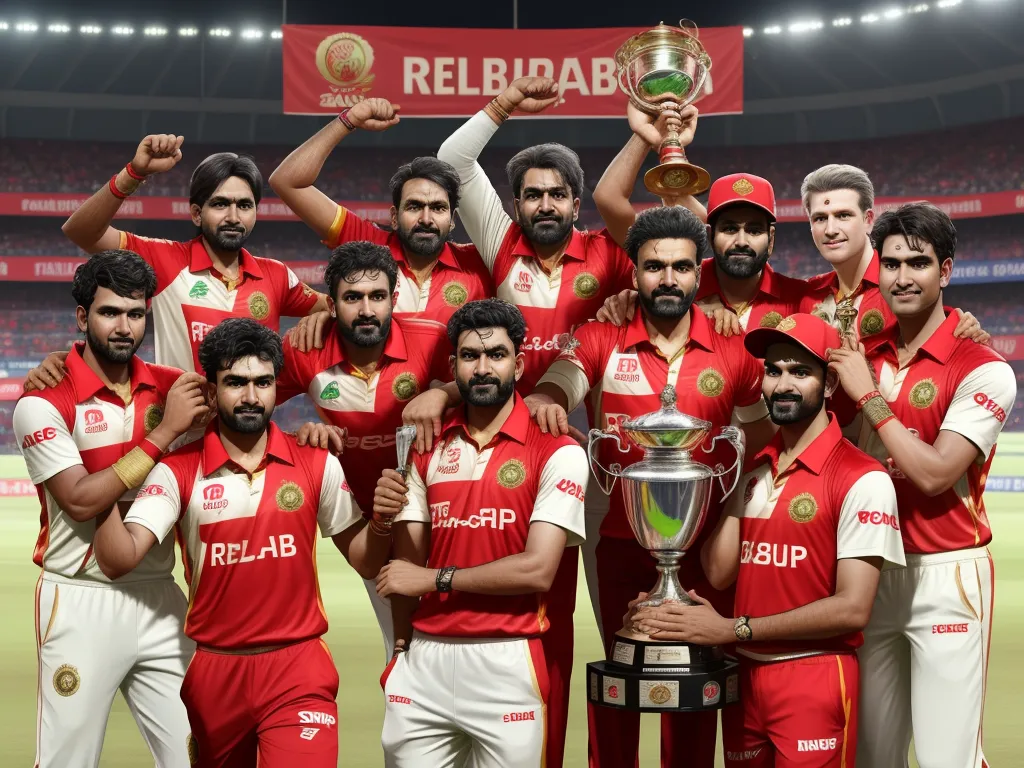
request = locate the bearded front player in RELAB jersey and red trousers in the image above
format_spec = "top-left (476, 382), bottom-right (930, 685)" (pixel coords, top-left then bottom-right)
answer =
top-left (95, 318), bottom-right (391, 768)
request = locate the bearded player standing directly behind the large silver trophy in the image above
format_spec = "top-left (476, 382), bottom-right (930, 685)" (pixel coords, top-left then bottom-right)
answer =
top-left (527, 206), bottom-right (773, 768)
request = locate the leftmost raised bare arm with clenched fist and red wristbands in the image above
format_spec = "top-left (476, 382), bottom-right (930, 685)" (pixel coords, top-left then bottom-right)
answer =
top-left (60, 133), bottom-right (184, 253)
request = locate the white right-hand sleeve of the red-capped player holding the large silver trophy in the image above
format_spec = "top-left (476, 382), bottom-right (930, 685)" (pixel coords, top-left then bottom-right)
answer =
top-left (837, 469), bottom-right (906, 565)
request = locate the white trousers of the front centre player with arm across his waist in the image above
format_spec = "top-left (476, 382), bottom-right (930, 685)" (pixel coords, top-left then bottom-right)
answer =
top-left (381, 633), bottom-right (547, 768)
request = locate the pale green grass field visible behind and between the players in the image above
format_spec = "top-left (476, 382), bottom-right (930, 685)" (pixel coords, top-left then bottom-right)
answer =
top-left (0, 434), bottom-right (1024, 768)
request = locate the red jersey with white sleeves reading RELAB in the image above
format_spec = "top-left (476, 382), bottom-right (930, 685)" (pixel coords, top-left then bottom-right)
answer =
top-left (125, 422), bottom-right (360, 649)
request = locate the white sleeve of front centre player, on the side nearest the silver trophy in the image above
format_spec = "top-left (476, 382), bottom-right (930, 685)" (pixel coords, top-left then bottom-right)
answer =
top-left (529, 445), bottom-right (590, 547)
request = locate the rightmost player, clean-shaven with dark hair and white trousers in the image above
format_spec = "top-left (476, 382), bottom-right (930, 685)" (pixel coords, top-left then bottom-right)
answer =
top-left (830, 203), bottom-right (1017, 768)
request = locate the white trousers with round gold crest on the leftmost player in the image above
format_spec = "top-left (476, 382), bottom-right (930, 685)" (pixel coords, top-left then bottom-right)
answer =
top-left (36, 571), bottom-right (196, 768)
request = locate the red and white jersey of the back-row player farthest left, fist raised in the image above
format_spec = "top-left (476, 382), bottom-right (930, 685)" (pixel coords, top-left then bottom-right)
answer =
top-left (121, 232), bottom-right (317, 372)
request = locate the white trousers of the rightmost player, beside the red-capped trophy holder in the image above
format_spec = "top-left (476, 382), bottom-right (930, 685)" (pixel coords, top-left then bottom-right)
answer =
top-left (857, 547), bottom-right (995, 768)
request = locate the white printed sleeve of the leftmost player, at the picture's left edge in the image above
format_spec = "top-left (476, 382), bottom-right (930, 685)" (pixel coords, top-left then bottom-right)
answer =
top-left (13, 397), bottom-right (82, 485)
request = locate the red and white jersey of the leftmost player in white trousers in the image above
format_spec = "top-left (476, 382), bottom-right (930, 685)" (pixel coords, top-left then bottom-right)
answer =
top-left (14, 342), bottom-right (181, 582)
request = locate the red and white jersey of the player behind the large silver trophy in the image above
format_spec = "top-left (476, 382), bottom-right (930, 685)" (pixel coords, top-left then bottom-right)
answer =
top-left (541, 308), bottom-right (768, 539)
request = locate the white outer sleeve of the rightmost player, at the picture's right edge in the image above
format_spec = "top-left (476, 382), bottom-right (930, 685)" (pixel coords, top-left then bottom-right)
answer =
top-left (939, 360), bottom-right (1017, 456)
